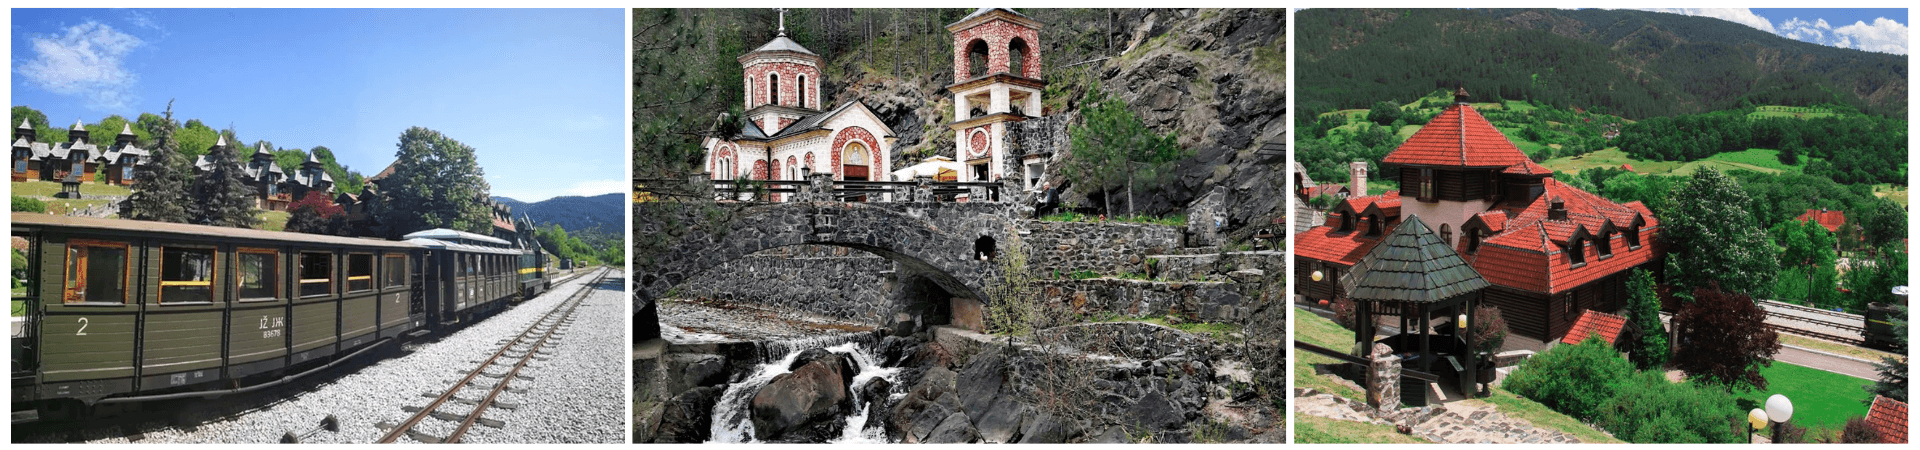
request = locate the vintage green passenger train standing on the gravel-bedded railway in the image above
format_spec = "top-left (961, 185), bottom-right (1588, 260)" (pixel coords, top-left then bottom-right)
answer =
top-left (12, 213), bottom-right (551, 423)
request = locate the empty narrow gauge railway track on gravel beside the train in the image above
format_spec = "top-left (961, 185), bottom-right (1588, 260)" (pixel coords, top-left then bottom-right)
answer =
top-left (378, 269), bottom-right (609, 444)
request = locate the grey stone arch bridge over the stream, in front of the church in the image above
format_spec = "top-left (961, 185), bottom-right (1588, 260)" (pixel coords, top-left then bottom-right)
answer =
top-left (630, 175), bottom-right (1018, 340)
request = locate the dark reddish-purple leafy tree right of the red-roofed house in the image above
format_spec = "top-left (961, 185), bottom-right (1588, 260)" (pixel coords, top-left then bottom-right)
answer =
top-left (1672, 287), bottom-right (1780, 390)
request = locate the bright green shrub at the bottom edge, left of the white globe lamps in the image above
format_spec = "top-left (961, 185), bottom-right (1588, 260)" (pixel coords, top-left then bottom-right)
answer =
top-left (1594, 371), bottom-right (1745, 444)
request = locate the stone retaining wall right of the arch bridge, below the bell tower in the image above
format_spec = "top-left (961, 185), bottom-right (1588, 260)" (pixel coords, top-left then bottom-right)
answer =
top-left (1021, 221), bottom-right (1183, 275)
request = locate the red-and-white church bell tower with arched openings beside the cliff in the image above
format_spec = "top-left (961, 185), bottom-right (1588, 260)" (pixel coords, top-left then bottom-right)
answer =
top-left (947, 8), bottom-right (1046, 181)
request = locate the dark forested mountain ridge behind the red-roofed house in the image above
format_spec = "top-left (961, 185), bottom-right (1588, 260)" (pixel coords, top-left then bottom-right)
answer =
top-left (1294, 10), bottom-right (1907, 121)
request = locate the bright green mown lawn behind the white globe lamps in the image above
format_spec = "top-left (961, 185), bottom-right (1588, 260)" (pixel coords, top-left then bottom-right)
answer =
top-left (1734, 362), bottom-right (1874, 431)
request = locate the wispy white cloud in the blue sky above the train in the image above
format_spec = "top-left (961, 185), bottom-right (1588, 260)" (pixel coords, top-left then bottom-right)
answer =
top-left (13, 21), bottom-right (144, 110)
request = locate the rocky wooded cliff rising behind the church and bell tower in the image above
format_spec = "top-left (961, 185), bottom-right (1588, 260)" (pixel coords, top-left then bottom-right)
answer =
top-left (634, 10), bottom-right (1286, 223)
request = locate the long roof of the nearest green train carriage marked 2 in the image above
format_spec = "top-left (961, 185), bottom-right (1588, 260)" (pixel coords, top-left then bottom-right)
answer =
top-left (12, 212), bottom-right (419, 250)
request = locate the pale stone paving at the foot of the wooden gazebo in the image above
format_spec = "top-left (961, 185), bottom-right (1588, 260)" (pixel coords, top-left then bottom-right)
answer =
top-left (1294, 388), bottom-right (1580, 444)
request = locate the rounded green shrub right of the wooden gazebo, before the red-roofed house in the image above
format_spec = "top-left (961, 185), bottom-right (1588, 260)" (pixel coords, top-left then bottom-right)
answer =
top-left (1505, 337), bottom-right (1634, 421)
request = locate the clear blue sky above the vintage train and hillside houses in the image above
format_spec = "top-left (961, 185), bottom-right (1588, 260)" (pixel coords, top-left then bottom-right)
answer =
top-left (8, 10), bottom-right (628, 202)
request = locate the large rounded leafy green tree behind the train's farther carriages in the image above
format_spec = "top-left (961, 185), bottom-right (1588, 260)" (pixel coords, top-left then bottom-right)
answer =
top-left (372, 127), bottom-right (493, 238)
